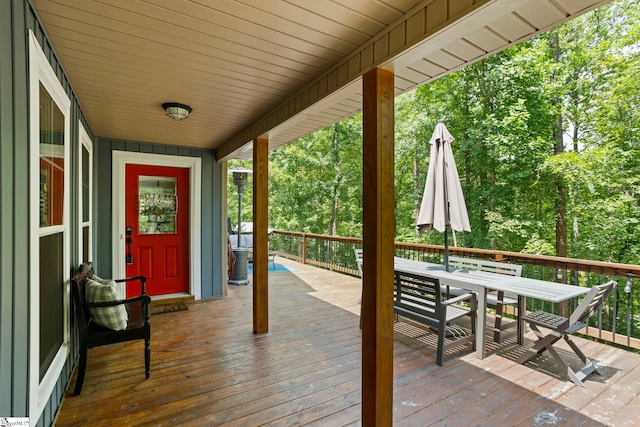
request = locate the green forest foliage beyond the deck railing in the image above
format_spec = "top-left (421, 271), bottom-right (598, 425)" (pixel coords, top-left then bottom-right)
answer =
top-left (228, 0), bottom-right (640, 264)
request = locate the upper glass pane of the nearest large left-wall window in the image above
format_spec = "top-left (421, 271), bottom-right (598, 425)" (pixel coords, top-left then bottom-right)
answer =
top-left (40, 84), bottom-right (64, 231)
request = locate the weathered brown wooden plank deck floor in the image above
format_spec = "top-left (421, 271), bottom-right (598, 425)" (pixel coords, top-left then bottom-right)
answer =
top-left (56, 258), bottom-right (640, 427)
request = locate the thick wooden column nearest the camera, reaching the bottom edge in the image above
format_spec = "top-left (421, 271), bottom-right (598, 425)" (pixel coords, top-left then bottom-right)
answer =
top-left (362, 69), bottom-right (395, 426)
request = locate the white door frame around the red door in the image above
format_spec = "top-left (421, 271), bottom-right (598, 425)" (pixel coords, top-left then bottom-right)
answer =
top-left (111, 150), bottom-right (202, 299)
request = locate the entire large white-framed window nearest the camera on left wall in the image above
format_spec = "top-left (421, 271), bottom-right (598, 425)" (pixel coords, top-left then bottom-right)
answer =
top-left (29, 33), bottom-right (71, 420)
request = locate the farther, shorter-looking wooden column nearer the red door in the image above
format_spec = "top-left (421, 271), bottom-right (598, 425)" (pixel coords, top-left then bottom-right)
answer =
top-left (253, 138), bottom-right (269, 334)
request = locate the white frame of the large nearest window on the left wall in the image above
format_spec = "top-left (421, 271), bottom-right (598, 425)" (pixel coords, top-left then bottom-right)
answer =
top-left (29, 30), bottom-right (71, 420)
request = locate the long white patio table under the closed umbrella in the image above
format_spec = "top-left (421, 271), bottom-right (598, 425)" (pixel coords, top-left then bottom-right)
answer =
top-left (394, 257), bottom-right (589, 359)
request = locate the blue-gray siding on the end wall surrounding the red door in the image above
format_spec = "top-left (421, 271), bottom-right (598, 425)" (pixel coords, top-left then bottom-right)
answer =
top-left (94, 138), bottom-right (226, 298)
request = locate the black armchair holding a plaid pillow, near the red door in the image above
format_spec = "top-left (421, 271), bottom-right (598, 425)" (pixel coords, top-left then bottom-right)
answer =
top-left (71, 263), bottom-right (151, 396)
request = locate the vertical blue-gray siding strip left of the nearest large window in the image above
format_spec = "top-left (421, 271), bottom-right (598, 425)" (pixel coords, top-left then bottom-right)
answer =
top-left (0, 0), bottom-right (29, 422)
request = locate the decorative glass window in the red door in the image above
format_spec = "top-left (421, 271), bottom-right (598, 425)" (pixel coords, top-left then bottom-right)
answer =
top-left (138, 176), bottom-right (178, 234)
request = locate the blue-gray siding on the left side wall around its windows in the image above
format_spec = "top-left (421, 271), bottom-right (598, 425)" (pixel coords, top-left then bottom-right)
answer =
top-left (0, 0), bottom-right (93, 426)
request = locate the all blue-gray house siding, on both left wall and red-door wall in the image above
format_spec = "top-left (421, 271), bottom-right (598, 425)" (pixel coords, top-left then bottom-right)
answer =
top-left (0, 0), bottom-right (223, 426)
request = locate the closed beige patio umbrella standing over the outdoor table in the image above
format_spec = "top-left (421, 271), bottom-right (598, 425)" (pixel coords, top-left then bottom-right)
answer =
top-left (416, 123), bottom-right (471, 271)
